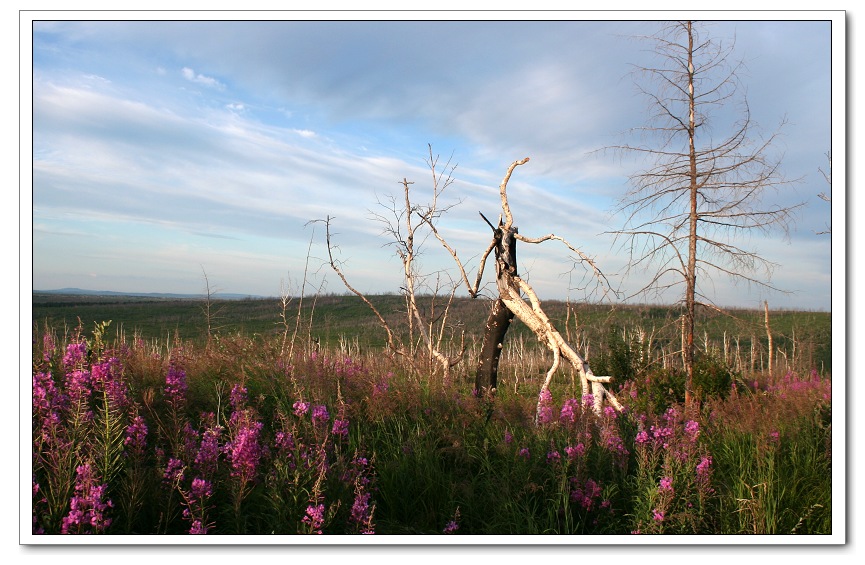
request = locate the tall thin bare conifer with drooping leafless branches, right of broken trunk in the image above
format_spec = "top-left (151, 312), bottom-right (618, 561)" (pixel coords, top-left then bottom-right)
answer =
top-left (613, 21), bottom-right (802, 406)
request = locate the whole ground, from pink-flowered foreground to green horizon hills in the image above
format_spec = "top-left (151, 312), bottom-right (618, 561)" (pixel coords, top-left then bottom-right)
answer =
top-left (32, 294), bottom-right (833, 535)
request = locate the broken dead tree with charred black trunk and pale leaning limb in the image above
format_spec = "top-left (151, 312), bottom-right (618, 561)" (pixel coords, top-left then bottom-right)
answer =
top-left (422, 157), bottom-right (622, 413)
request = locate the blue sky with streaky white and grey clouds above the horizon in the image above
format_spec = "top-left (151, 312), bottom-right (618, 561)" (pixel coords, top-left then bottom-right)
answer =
top-left (22, 12), bottom-right (844, 310)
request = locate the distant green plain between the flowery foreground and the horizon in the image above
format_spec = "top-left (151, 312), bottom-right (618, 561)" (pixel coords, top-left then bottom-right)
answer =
top-left (33, 293), bottom-right (832, 373)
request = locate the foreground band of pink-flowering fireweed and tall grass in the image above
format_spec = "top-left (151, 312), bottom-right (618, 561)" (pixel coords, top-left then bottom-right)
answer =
top-left (32, 323), bottom-right (832, 535)
